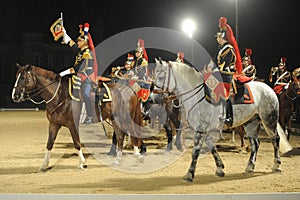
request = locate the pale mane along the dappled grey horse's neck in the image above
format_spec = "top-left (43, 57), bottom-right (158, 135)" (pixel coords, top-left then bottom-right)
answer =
top-left (169, 61), bottom-right (203, 86)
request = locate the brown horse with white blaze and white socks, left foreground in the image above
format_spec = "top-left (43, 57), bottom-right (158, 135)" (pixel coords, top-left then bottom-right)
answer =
top-left (12, 64), bottom-right (141, 171)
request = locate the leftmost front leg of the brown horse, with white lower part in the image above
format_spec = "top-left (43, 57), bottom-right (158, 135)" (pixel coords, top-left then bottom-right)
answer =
top-left (40, 123), bottom-right (61, 172)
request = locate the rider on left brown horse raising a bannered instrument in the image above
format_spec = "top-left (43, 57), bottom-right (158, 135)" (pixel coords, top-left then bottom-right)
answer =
top-left (50, 18), bottom-right (98, 124)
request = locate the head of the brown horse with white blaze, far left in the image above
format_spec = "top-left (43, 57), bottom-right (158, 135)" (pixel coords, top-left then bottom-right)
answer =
top-left (12, 63), bottom-right (36, 102)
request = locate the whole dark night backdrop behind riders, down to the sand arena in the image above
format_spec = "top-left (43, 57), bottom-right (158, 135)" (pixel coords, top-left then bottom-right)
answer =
top-left (0, 0), bottom-right (300, 108)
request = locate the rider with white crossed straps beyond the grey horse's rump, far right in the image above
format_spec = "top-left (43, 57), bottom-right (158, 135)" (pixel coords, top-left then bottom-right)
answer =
top-left (269, 57), bottom-right (291, 96)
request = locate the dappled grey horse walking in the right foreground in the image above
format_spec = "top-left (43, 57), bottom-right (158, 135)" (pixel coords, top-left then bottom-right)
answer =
top-left (154, 60), bottom-right (281, 182)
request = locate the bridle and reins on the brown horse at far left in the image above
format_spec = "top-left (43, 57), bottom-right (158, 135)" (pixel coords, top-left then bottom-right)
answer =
top-left (14, 67), bottom-right (61, 104)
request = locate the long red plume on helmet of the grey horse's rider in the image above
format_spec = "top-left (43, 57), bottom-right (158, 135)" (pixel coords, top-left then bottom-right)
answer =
top-left (219, 17), bottom-right (243, 74)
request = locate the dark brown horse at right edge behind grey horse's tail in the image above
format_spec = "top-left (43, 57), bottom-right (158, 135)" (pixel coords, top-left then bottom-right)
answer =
top-left (279, 79), bottom-right (300, 140)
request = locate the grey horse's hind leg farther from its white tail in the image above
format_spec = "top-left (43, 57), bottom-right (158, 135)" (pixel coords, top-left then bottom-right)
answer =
top-left (243, 117), bottom-right (260, 173)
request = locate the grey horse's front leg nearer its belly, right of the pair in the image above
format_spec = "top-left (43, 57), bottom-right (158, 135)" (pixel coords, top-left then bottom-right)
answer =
top-left (205, 134), bottom-right (225, 177)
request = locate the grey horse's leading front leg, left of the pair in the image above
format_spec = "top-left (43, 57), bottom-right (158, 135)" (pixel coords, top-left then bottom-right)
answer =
top-left (183, 132), bottom-right (206, 182)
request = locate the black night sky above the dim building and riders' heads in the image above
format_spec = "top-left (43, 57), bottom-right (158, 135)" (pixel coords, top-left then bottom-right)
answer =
top-left (0, 0), bottom-right (300, 71)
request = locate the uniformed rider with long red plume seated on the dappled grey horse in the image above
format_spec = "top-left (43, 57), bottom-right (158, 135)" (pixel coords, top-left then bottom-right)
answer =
top-left (204, 17), bottom-right (243, 126)
